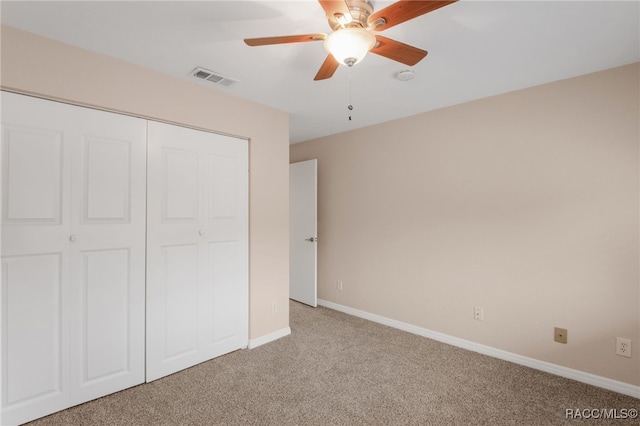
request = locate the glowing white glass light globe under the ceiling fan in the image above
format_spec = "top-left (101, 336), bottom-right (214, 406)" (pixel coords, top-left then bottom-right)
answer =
top-left (324, 28), bottom-right (376, 67)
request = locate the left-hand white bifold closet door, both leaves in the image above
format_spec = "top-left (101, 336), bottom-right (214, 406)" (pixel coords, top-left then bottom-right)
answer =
top-left (0, 92), bottom-right (146, 425)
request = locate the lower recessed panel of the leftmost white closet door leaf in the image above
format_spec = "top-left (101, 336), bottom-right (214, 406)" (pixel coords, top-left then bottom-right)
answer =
top-left (2, 253), bottom-right (65, 407)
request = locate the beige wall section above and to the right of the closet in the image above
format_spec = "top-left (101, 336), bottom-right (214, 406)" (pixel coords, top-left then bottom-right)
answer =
top-left (0, 26), bottom-right (289, 339)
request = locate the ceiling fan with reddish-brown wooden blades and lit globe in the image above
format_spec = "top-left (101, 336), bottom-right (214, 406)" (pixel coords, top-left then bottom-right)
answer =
top-left (244, 0), bottom-right (458, 80)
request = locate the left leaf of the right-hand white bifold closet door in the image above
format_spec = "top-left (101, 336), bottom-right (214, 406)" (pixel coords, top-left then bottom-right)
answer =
top-left (146, 122), bottom-right (202, 381)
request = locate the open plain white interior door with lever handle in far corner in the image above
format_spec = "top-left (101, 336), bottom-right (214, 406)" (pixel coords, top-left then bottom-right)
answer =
top-left (289, 160), bottom-right (318, 307)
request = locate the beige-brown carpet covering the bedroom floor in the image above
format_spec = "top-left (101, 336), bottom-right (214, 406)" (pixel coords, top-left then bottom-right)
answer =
top-left (32, 302), bottom-right (640, 426)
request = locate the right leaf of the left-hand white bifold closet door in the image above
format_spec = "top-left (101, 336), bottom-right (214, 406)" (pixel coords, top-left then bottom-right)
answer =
top-left (70, 108), bottom-right (146, 402)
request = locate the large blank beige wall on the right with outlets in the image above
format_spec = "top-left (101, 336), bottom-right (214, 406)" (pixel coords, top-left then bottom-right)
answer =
top-left (290, 64), bottom-right (640, 385)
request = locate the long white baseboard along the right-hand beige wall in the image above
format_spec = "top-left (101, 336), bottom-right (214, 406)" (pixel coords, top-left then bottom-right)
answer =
top-left (318, 299), bottom-right (640, 399)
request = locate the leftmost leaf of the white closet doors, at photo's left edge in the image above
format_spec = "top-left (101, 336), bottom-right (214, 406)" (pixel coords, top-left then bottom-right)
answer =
top-left (0, 92), bottom-right (73, 424)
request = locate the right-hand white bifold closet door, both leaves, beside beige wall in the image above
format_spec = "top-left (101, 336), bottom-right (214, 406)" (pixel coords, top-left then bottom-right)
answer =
top-left (147, 122), bottom-right (248, 381)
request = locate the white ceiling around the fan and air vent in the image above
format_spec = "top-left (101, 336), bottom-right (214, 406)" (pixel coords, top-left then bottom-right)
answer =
top-left (0, 0), bottom-right (640, 143)
